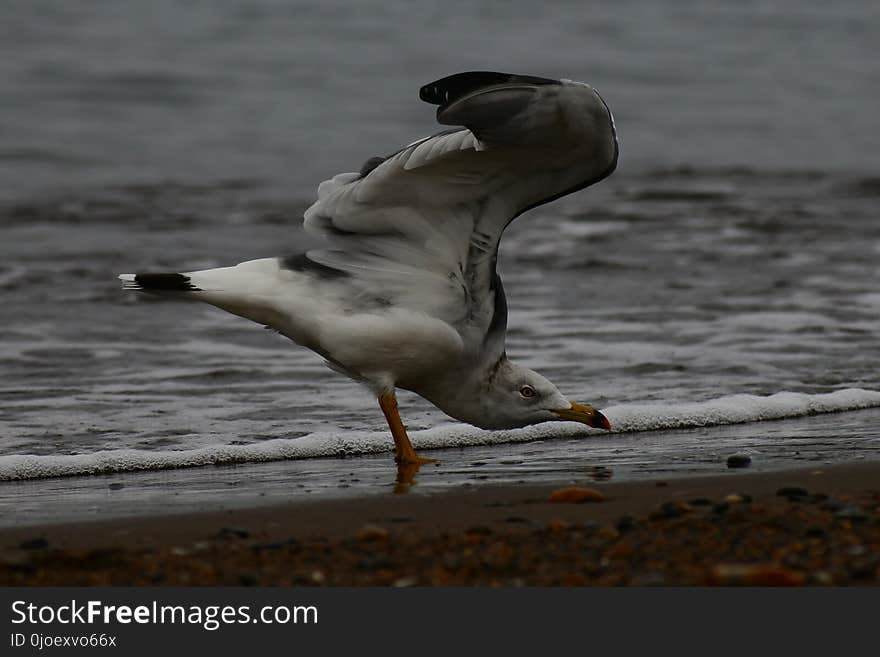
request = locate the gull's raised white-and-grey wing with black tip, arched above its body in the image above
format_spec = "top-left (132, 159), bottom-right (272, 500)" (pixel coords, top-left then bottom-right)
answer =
top-left (293, 72), bottom-right (618, 358)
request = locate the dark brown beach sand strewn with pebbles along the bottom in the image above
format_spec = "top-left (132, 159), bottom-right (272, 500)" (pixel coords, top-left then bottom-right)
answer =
top-left (0, 463), bottom-right (880, 586)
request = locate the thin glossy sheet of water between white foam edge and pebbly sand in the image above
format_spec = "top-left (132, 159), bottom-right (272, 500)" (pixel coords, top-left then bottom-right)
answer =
top-left (6, 408), bottom-right (880, 532)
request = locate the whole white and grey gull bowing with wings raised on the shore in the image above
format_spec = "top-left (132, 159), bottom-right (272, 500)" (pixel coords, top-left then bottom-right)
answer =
top-left (119, 71), bottom-right (618, 481)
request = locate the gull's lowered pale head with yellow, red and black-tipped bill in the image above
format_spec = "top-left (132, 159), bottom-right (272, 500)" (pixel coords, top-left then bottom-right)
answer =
top-left (461, 358), bottom-right (611, 430)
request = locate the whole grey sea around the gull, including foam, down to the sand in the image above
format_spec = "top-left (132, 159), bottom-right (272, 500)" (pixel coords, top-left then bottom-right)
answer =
top-left (0, 1), bottom-right (880, 522)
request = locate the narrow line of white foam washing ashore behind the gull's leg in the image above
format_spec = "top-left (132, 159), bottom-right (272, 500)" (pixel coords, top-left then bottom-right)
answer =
top-left (0, 388), bottom-right (880, 481)
